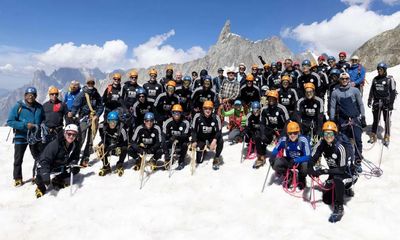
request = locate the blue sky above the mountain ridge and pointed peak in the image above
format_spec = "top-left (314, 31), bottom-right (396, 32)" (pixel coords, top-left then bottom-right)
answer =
top-left (0, 0), bottom-right (400, 89)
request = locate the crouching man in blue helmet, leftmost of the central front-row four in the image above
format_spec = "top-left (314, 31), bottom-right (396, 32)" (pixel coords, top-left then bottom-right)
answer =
top-left (98, 111), bottom-right (128, 176)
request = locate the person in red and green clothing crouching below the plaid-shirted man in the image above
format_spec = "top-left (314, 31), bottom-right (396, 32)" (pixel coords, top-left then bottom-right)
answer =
top-left (222, 100), bottom-right (247, 143)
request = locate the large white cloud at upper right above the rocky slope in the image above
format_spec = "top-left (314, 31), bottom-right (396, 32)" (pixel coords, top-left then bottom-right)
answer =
top-left (281, 5), bottom-right (400, 55)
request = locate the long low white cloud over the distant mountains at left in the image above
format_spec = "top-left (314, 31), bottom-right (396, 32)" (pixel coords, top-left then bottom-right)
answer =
top-left (34, 40), bottom-right (128, 70)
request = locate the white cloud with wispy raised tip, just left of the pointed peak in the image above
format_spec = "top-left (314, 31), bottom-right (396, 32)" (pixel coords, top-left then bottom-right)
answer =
top-left (131, 30), bottom-right (206, 67)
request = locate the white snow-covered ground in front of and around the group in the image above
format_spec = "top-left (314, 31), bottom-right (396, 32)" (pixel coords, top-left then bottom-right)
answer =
top-left (0, 66), bottom-right (400, 239)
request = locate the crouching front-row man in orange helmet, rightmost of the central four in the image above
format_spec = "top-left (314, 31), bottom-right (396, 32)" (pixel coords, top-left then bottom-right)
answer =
top-left (191, 100), bottom-right (223, 170)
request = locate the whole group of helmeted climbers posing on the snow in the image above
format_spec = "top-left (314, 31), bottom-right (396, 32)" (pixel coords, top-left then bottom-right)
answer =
top-left (7, 52), bottom-right (397, 220)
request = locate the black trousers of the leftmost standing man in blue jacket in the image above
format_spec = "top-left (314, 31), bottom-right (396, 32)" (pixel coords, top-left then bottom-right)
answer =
top-left (13, 143), bottom-right (42, 180)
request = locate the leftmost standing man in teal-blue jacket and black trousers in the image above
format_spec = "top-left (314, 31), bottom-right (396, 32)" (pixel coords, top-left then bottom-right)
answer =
top-left (7, 87), bottom-right (44, 187)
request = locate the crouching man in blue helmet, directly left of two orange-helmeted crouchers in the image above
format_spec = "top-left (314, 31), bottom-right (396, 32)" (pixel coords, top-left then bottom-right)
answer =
top-left (128, 112), bottom-right (163, 171)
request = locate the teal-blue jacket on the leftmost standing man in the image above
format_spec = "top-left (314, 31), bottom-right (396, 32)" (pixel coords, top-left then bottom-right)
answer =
top-left (7, 101), bottom-right (44, 144)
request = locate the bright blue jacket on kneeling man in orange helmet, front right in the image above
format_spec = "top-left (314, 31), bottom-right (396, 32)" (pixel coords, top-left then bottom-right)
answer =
top-left (272, 135), bottom-right (311, 163)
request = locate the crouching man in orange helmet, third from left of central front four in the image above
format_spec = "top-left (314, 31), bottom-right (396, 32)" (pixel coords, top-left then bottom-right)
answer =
top-left (162, 104), bottom-right (190, 170)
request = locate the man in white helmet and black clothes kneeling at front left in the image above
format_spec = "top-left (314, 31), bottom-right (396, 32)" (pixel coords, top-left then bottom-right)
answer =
top-left (35, 124), bottom-right (80, 198)
